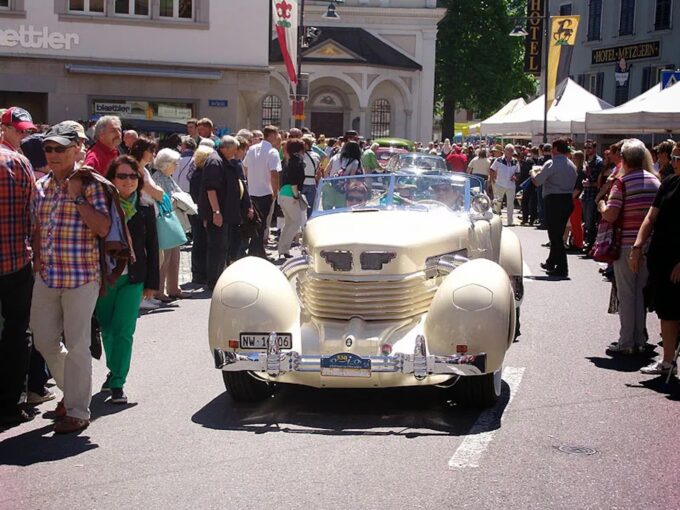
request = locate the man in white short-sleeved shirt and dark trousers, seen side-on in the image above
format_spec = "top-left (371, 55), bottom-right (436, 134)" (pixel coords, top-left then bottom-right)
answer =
top-left (243, 126), bottom-right (281, 258)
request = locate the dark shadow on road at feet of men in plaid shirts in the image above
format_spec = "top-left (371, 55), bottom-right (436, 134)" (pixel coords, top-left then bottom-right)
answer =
top-left (0, 424), bottom-right (99, 466)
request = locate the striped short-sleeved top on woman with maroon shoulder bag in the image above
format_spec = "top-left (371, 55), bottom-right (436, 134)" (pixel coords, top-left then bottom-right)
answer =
top-left (607, 170), bottom-right (659, 246)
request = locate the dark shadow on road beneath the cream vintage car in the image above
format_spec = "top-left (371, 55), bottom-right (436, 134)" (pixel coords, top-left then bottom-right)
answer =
top-left (192, 382), bottom-right (510, 439)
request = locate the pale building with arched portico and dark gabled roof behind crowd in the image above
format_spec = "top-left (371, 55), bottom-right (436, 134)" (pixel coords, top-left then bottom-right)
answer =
top-left (261, 0), bottom-right (445, 142)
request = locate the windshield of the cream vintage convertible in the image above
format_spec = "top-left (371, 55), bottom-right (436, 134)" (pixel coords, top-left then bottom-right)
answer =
top-left (313, 174), bottom-right (483, 216)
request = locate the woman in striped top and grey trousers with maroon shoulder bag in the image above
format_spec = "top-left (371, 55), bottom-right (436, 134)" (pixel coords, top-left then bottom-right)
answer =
top-left (597, 139), bottom-right (659, 354)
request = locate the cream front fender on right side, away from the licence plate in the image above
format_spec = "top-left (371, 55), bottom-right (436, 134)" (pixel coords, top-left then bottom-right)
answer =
top-left (424, 259), bottom-right (515, 373)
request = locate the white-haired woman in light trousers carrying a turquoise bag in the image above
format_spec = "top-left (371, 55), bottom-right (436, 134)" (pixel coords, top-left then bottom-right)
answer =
top-left (153, 149), bottom-right (189, 302)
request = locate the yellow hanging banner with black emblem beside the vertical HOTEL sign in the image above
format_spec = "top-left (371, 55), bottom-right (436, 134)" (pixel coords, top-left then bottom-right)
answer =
top-left (547, 16), bottom-right (579, 106)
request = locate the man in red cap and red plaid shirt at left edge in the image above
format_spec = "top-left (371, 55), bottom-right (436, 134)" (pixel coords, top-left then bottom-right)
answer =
top-left (0, 146), bottom-right (35, 425)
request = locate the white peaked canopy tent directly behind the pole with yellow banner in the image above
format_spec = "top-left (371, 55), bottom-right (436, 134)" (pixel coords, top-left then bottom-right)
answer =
top-left (482, 78), bottom-right (612, 138)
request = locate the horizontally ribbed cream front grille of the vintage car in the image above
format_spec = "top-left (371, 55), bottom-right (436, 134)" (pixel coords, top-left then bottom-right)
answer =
top-left (297, 272), bottom-right (437, 321)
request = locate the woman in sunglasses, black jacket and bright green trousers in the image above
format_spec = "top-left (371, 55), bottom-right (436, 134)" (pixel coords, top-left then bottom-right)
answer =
top-left (95, 156), bottom-right (159, 404)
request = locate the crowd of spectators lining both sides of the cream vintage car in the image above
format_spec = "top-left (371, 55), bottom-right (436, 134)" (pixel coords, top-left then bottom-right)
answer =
top-left (0, 107), bottom-right (680, 433)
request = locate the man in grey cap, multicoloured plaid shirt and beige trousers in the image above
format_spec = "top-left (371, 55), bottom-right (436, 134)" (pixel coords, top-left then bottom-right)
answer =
top-left (31, 124), bottom-right (111, 433)
